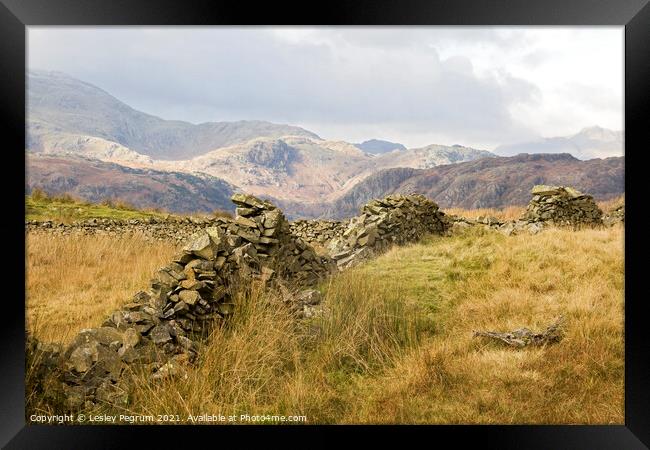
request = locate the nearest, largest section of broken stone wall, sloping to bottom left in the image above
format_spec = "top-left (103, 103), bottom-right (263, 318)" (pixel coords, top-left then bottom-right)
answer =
top-left (36, 194), bottom-right (335, 407)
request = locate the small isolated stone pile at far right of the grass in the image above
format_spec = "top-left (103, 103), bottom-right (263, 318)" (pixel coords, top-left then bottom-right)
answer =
top-left (522, 185), bottom-right (603, 226)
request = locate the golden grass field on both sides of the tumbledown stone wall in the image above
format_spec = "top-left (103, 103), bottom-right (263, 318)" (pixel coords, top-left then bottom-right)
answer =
top-left (27, 226), bottom-right (624, 424)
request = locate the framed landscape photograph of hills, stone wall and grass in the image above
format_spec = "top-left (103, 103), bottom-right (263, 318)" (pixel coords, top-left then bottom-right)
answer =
top-left (24, 26), bottom-right (625, 425)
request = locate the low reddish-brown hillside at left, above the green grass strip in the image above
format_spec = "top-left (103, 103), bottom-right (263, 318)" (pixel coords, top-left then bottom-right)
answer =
top-left (25, 155), bottom-right (234, 212)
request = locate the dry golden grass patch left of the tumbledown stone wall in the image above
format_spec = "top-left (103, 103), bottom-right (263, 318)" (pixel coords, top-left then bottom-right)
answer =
top-left (26, 233), bottom-right (174, 342)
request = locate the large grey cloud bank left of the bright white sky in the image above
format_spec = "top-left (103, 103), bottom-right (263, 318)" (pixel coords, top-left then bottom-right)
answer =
top-left (29, 27), bottom-right (556, 145)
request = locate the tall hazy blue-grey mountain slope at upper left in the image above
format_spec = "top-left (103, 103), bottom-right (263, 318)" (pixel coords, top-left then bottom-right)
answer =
top-left (27, 71), bottom-right (319, 160)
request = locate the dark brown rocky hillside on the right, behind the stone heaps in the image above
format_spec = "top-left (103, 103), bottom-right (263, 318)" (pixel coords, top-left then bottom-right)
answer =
top-left (323, 154), bottom-right (625, 218)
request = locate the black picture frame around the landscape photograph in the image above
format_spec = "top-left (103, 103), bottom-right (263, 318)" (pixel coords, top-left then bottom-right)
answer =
top-left (0, 0), bottom-right (650, 449)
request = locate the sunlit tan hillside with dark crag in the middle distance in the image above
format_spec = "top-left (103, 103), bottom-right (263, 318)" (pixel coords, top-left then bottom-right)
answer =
top-left (154, 136), bottom-right (494, 202)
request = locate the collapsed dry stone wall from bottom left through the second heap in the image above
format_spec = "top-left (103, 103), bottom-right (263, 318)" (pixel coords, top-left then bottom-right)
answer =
top-left (28, 194), bottom-right (454, 407)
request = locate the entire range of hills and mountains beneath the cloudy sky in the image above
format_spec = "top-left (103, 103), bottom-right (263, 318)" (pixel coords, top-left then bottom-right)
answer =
top-left (25, 70), bottom-right (623, 217)
